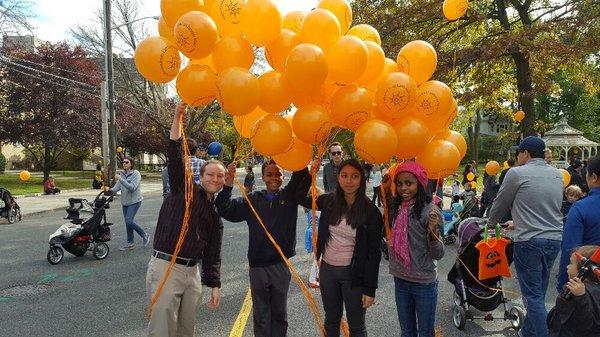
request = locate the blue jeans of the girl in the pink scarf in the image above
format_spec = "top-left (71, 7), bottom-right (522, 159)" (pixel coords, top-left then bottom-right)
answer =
top-left (394, 277), bottom-right (438, 337)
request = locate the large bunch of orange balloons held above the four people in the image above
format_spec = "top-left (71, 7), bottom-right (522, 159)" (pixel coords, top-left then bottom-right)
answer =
top-left (135, 0), bottom-right (467, 177)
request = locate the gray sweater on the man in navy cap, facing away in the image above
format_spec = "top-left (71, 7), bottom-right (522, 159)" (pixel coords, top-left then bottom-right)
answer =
top-left (489, 158), bottom-right (563, 242)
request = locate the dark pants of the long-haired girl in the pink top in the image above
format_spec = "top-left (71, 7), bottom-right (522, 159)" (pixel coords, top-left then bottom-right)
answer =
top-left (319, 261), bottom-right (367, 337)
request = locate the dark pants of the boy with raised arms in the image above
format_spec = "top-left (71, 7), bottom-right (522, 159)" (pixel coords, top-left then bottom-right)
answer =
top-left (250, 262), bottom-right (292, 337)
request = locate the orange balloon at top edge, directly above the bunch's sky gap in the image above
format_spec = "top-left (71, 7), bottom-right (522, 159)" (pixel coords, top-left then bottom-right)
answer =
top-left (240, 0), bottom-right (282, 47)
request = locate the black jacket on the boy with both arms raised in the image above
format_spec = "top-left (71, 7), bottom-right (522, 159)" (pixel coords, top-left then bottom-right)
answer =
top-left (217, 169), bottom-right (311, 267)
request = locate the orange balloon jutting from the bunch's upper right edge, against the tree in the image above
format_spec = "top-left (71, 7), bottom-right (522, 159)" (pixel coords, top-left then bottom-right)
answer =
top-left (396, 40), bottom-right (437, 85)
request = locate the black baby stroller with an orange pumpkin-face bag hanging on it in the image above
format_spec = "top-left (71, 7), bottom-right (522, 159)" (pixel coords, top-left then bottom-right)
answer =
top-left (448, 217), bottom-right (525, 330)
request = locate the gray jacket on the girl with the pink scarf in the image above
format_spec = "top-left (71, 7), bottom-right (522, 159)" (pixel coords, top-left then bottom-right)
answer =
top-left (390, 203), bottom-right (444, 283)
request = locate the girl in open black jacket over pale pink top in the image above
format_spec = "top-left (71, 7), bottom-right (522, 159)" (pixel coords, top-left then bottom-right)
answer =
top-left (304, 159), bottom-right (383, 337)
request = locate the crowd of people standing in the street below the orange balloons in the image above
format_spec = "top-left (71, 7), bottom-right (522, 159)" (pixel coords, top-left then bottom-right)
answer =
top-left (94, 104), bottom-right (600, 337)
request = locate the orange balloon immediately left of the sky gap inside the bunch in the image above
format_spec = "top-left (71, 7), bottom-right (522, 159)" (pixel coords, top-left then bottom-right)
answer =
top-left (212, 36), bottom-right (254, 73)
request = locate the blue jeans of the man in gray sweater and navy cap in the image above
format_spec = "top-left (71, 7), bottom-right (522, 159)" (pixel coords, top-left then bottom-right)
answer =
top-left (514, 238), bottom-right (560, 337)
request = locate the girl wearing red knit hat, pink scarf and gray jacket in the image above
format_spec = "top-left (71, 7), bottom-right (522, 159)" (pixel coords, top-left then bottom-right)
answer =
top-left (389, 161), bottom-right (444, 337)
